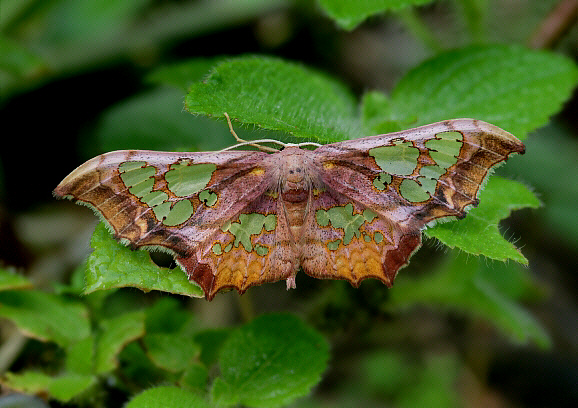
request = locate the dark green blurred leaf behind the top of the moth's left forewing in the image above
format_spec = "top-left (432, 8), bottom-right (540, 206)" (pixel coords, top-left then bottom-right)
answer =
top-left (92, 87), bottom-right (235, 156)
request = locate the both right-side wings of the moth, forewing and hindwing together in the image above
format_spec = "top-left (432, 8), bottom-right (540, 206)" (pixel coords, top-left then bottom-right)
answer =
top-left (302, 119), bottom-right (524, 285)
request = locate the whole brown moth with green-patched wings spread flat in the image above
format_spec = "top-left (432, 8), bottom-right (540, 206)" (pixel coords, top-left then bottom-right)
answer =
top-left (54, 116), bottom-right (525, 300)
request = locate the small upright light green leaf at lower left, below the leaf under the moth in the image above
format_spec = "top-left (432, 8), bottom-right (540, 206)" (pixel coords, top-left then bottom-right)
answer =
top-left (95, 311), bottom-right (145, 374)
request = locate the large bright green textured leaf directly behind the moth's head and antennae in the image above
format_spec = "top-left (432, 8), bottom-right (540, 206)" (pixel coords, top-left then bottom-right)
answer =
top-left (186, 57), bottom-right (362, 142)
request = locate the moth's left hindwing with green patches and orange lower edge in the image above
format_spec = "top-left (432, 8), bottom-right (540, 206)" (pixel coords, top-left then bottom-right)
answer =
top-left (176, 191), bottom-right (299, 300)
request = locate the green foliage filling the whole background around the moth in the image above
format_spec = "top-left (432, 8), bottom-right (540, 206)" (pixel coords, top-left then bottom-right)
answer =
top-left (0, 0), bottom-right (578, 408)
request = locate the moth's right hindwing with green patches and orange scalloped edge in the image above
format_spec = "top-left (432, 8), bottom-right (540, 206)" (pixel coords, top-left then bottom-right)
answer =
top-left (301, 187), bottom-right (421, 287)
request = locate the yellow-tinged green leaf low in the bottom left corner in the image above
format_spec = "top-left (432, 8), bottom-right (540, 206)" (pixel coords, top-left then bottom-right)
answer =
top-left (2, 371), bottom-right (96, 402)
